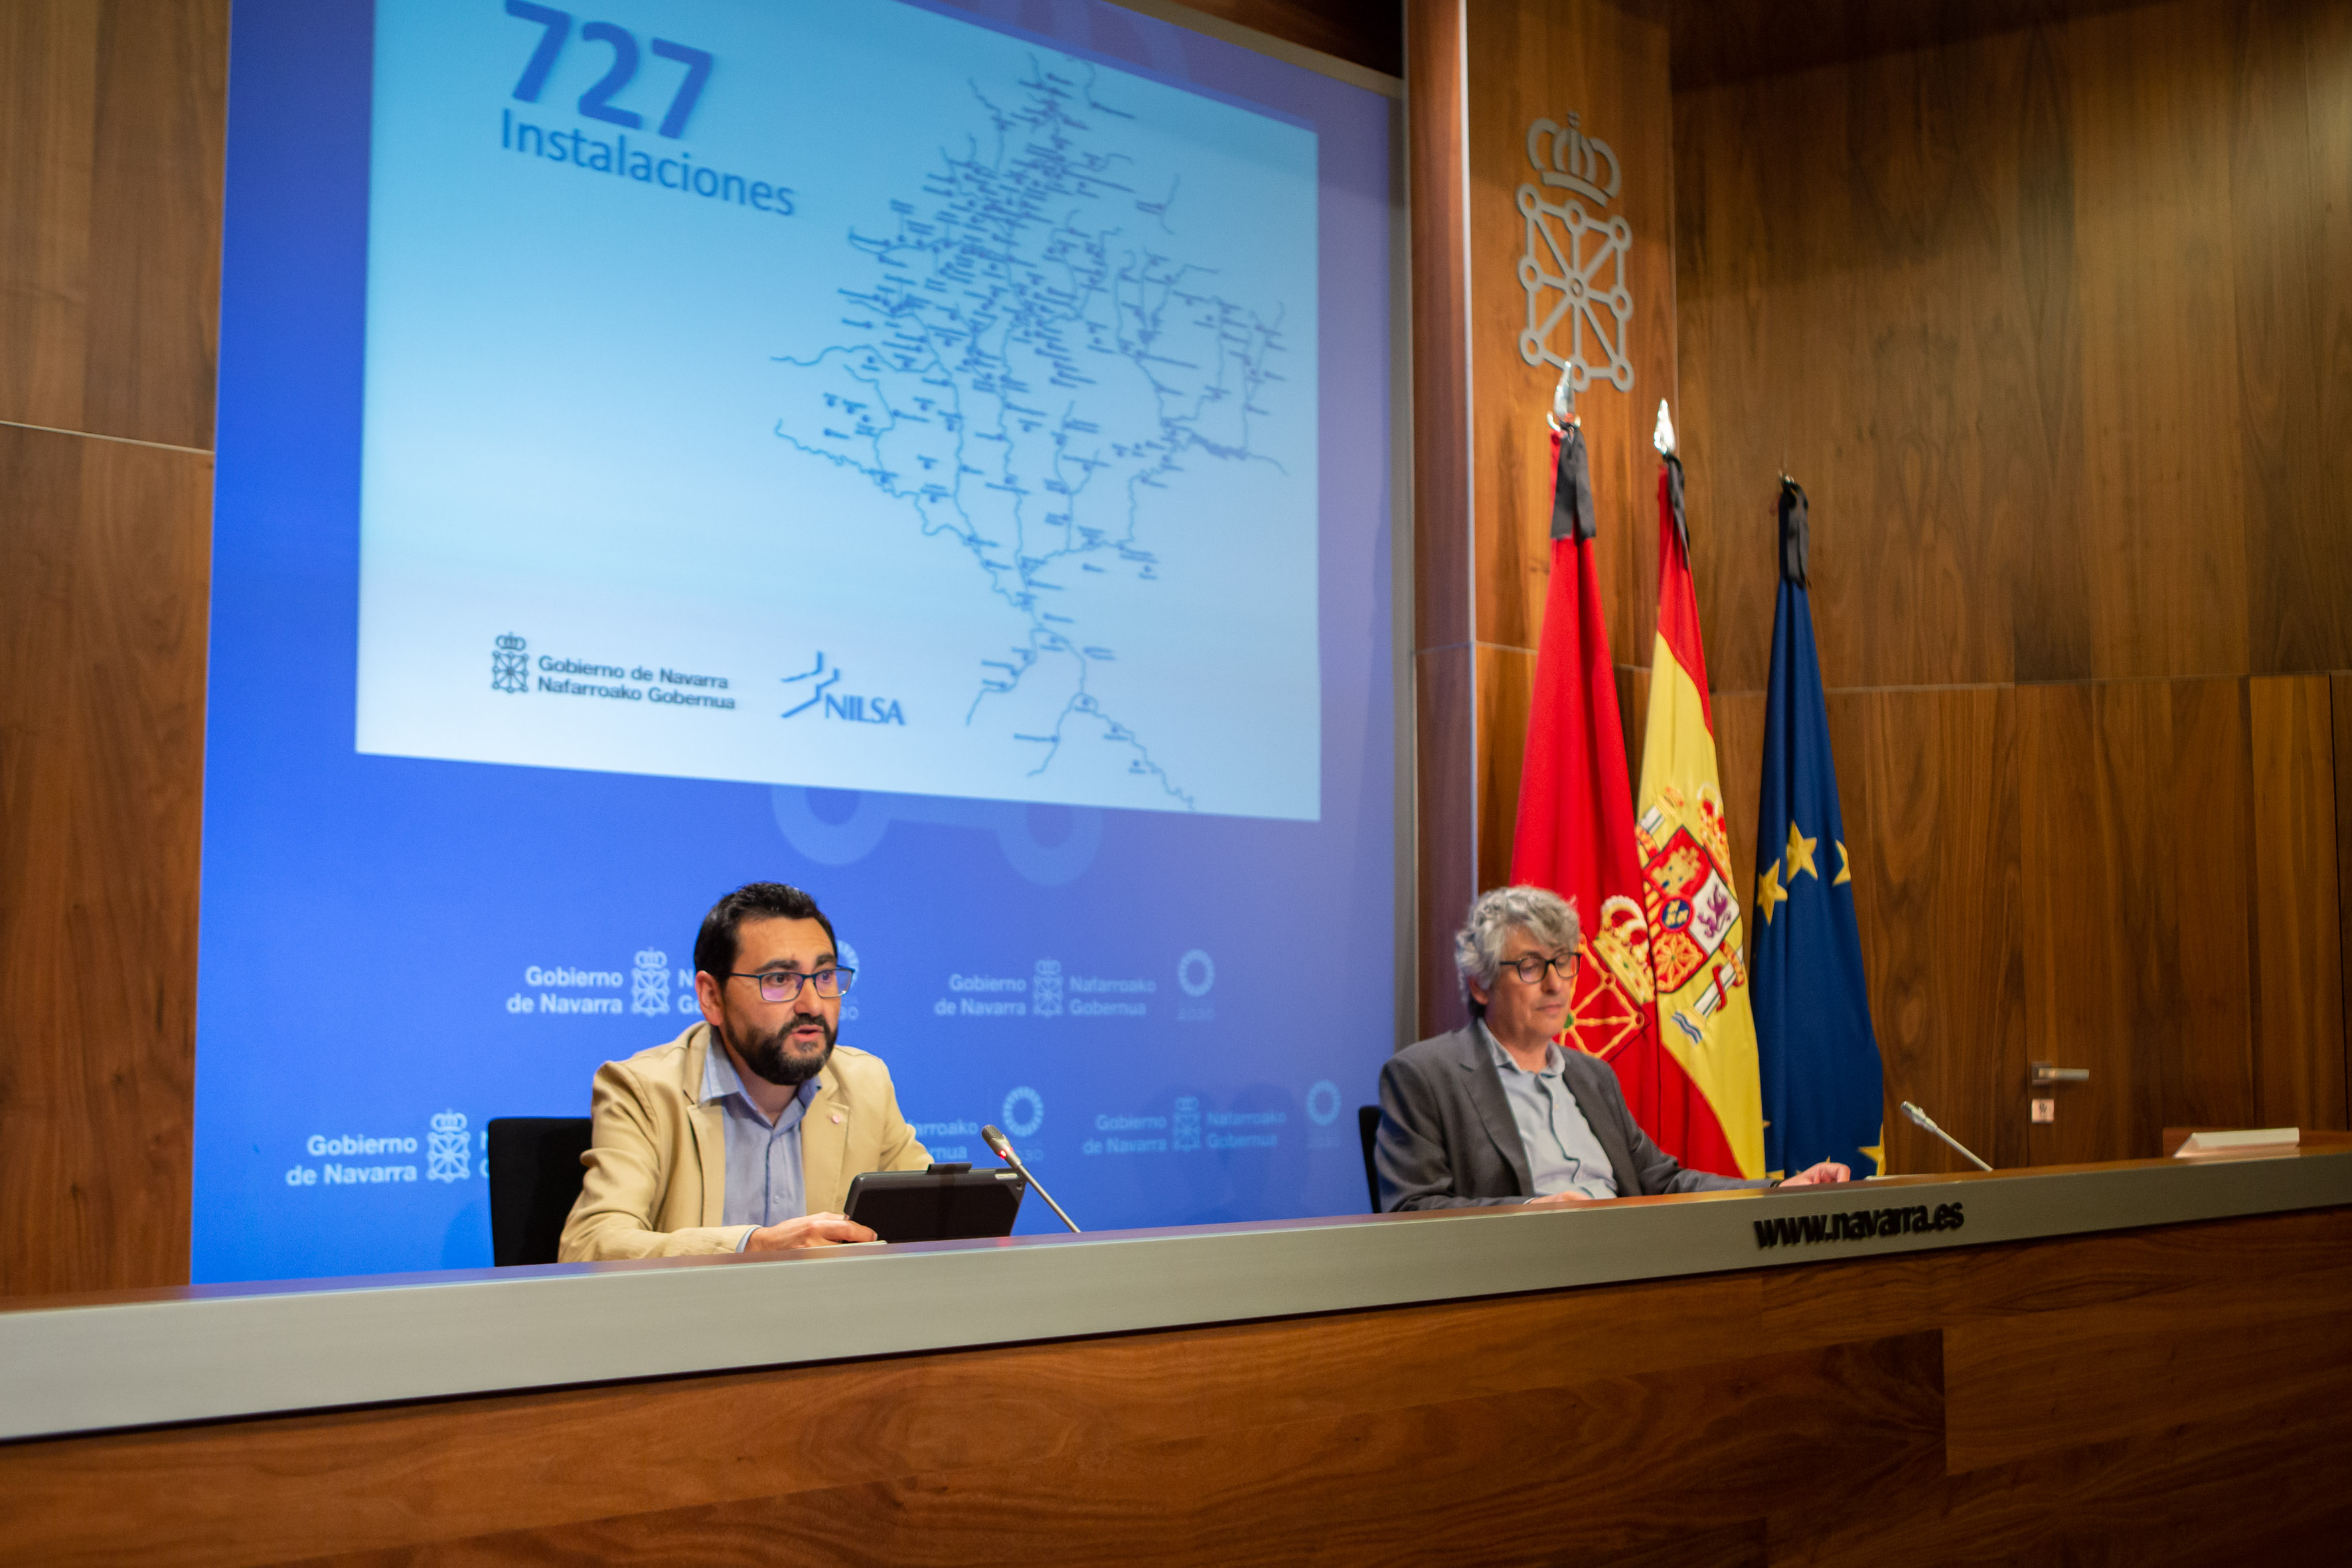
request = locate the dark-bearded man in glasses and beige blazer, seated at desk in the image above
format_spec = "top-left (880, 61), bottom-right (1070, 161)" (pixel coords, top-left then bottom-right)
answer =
top-left (560, 882), bottom-right (931, 1263)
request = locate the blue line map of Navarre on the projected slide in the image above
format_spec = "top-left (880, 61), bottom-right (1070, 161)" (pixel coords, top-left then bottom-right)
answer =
top-left (776, 61), bottom-right (1296, 809)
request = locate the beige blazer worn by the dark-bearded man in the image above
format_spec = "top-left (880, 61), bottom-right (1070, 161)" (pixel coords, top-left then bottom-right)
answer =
top-left (558, 1022), bottom-right (931, 1263)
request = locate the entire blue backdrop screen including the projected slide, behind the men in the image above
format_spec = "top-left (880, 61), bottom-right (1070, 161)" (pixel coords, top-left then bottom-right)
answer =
top-left (193, 0), bottom-right (1397, 1281)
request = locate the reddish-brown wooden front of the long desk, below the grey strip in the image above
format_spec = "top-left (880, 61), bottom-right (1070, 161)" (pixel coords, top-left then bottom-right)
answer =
top-left (0, 1154), bottom-right (2352, 1568)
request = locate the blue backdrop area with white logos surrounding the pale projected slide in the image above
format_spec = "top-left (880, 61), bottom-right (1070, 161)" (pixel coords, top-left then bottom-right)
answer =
top-left (193, 0), bottom-right (1395, 1281)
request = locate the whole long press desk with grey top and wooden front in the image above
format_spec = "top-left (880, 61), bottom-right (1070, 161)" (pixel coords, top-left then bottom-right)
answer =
top-left (0, 1145), bottom-right (2352, 1568)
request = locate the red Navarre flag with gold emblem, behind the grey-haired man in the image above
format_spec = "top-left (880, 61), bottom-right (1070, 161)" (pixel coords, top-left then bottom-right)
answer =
top-left (1510, 426), bottom-right (1689, 1128)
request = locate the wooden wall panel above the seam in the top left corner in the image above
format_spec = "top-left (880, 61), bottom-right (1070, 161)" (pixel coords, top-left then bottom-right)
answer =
top-left (0, 0), bottom-right (228, 449)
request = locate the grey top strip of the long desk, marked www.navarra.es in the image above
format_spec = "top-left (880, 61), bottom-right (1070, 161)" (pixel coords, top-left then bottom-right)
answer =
top-left (0, 1145), bottom-right (2352, 1441)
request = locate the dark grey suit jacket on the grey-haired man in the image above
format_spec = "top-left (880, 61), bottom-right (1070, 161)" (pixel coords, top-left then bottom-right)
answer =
top-left (1372, 1028), bottom-right (1771, 1213)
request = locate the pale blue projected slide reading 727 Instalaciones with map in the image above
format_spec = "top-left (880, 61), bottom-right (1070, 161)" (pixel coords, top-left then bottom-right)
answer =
top-left (355, 0), bottom-right (1336, 821)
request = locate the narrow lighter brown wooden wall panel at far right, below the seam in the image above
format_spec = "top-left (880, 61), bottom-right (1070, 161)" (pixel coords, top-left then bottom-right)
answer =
top-left (2246, 674), bottom-right (2347, 1129)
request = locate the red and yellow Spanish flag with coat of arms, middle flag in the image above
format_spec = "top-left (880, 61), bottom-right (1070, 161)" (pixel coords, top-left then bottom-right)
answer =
top-left (1634, 439), bottom-right (1764, 1178)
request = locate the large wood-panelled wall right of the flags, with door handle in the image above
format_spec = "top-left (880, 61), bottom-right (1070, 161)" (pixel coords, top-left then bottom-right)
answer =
top-left (1672, 0), bottom-right (2352, 1168)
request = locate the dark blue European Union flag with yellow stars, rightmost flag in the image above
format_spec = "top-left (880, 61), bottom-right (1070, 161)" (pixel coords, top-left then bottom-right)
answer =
top-left (1750, 479), bottom-right (1886, 1176)
